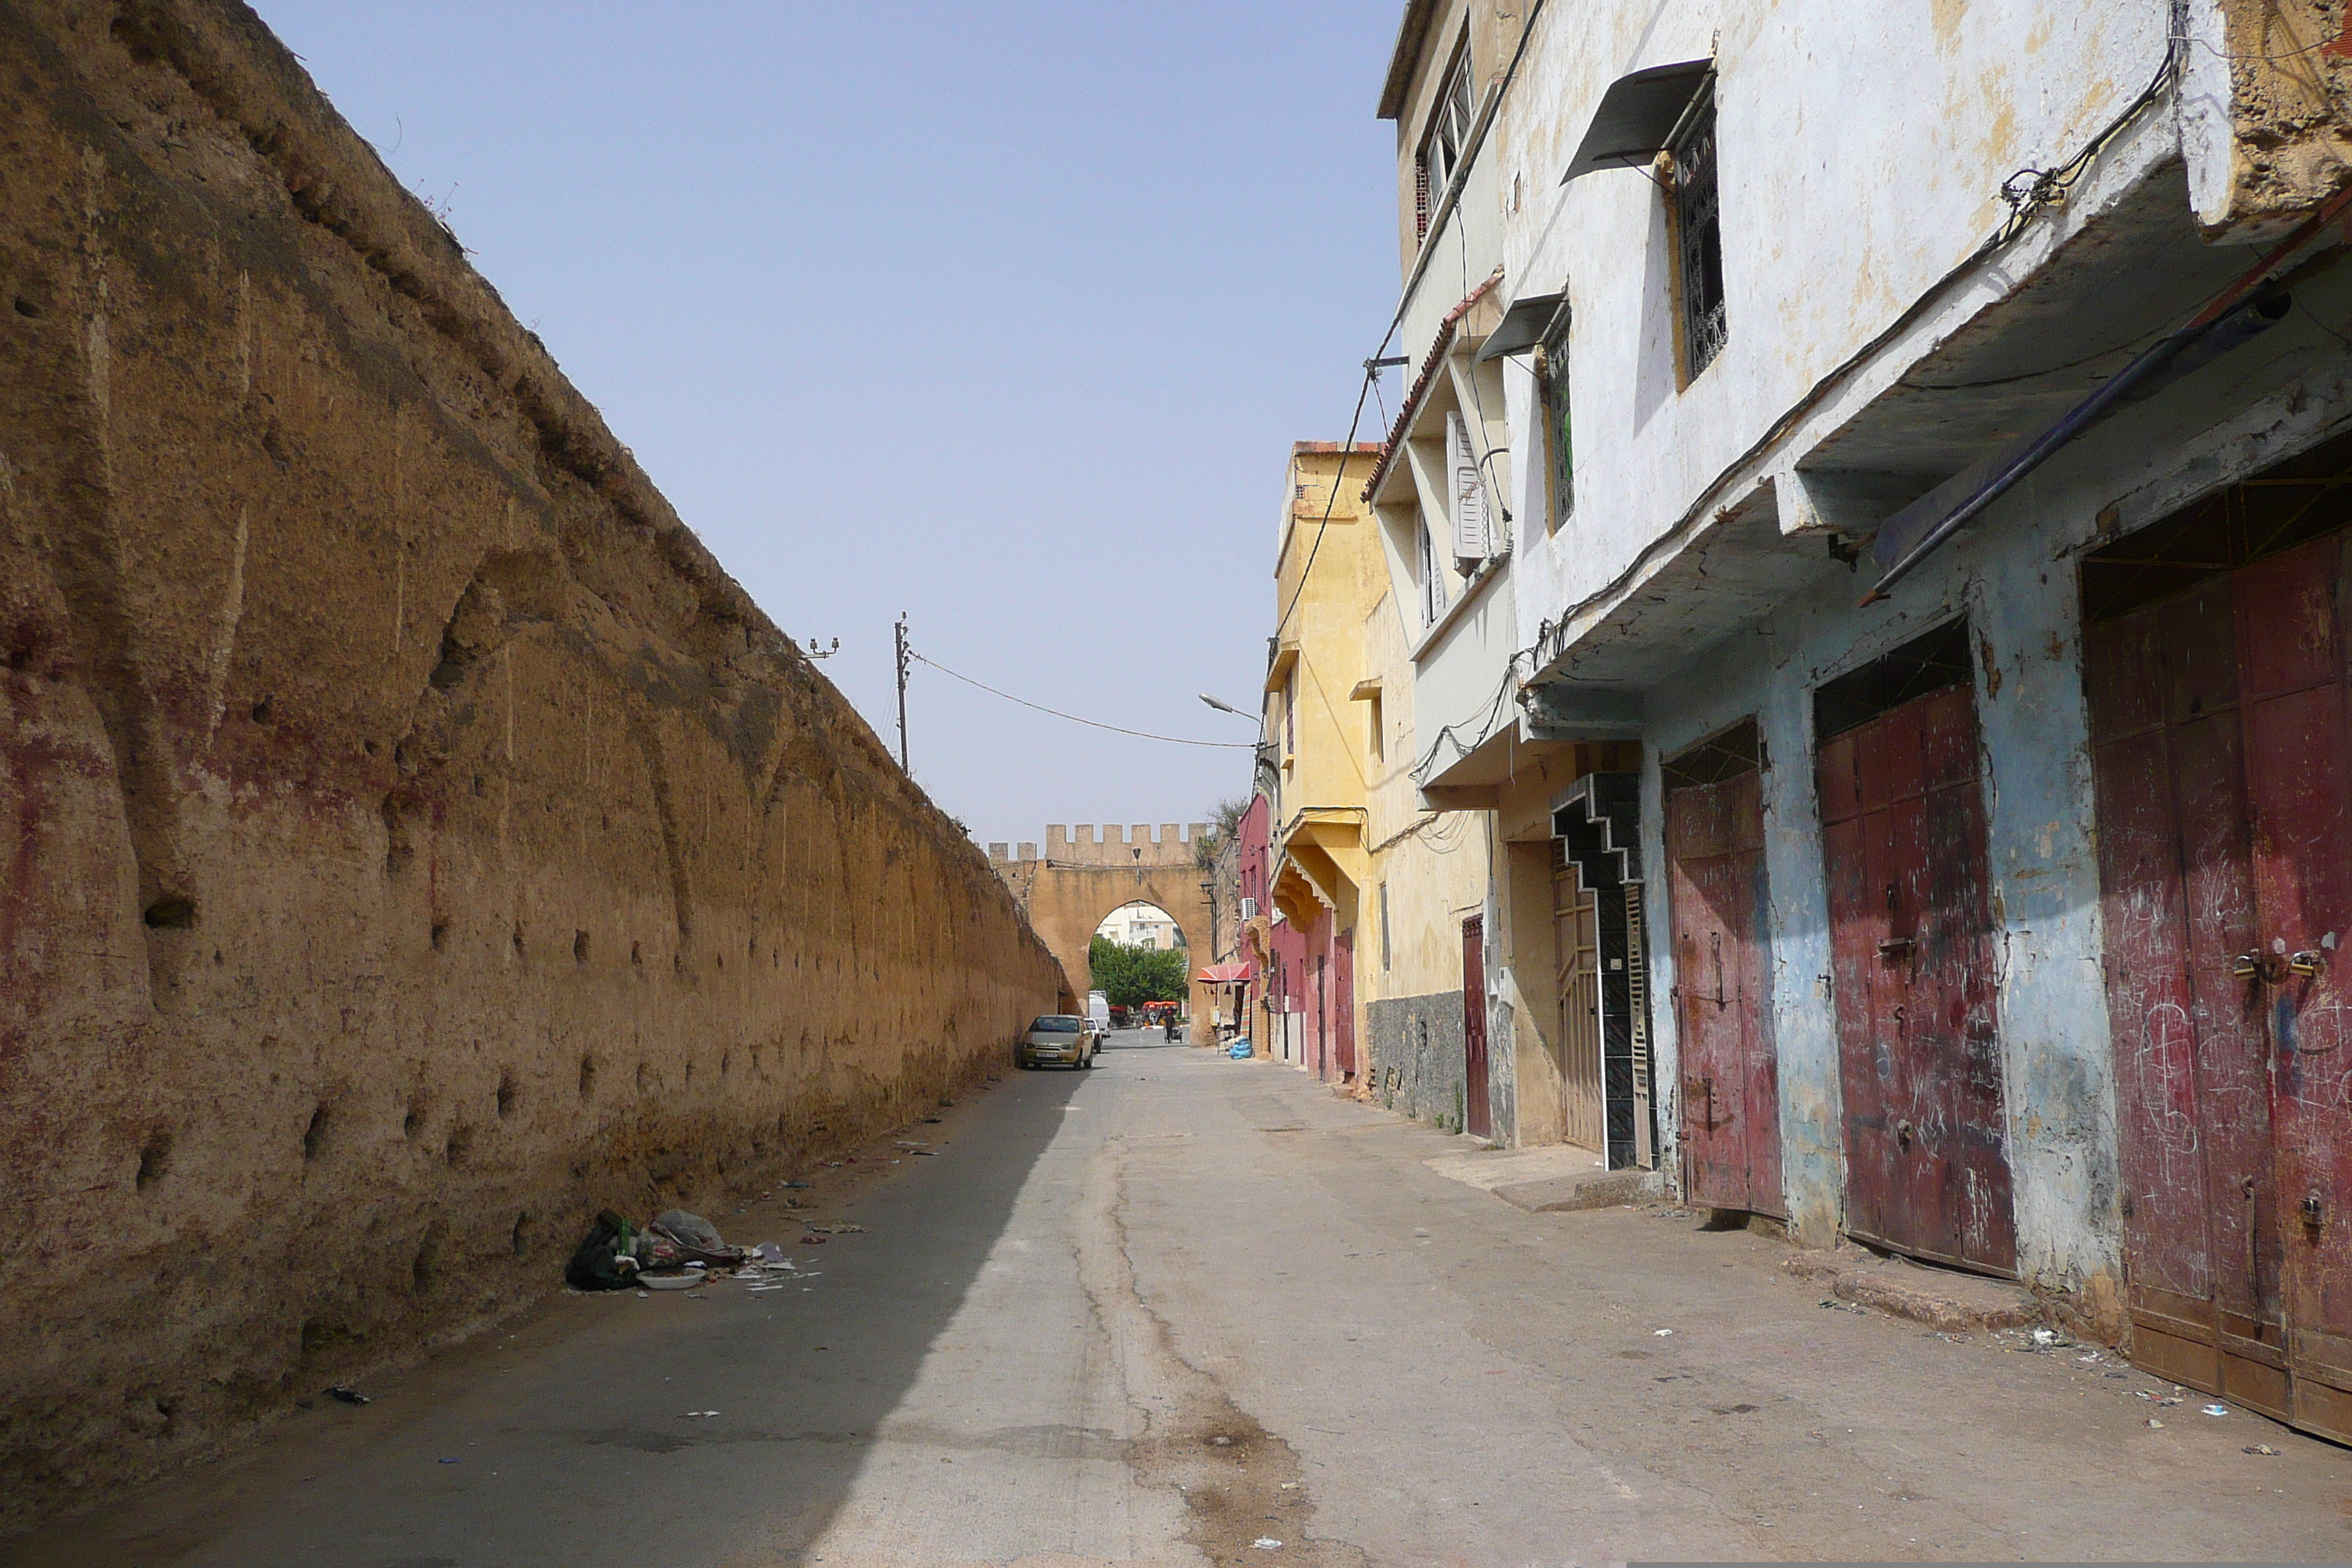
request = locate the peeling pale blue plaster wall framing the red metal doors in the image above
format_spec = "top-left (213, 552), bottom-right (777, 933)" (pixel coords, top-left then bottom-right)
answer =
top-left (1644, 270), bottom-right (2352, 1338)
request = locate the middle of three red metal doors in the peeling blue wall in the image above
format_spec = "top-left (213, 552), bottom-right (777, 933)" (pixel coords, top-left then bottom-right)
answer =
top-left (1818, 682), bottom-right (2018, 1274)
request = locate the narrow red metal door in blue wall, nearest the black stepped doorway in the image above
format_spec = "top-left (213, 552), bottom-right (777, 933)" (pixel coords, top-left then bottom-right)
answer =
top-left (1665, 766), bottom-right (1787, 1218)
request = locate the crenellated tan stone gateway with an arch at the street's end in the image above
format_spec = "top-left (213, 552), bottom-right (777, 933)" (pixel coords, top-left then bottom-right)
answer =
top-left (988, 823), bottom-right (1211, 1011)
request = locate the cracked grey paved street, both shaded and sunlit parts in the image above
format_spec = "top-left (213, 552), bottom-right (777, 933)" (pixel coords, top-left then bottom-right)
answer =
top-left (27, 1034), bottom-right (2352, 1568)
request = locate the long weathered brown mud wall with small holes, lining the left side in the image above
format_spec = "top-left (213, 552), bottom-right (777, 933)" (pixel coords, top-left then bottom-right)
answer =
top-left (0, 0), bottom-right (1060, 1518)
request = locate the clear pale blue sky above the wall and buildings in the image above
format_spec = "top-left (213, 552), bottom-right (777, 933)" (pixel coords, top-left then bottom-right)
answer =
top-left (259, 0), bottom-right (1402, 842)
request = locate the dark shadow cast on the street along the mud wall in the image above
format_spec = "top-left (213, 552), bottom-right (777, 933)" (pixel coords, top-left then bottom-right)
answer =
top-left (0, 1041), bottom-right (1101, 1568)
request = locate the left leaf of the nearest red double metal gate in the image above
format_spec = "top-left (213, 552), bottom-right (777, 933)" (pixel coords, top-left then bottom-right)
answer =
top-left (2084, 581), bottom-right (2288, 1417)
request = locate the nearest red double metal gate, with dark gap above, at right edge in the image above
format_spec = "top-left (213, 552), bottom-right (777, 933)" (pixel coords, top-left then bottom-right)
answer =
top-left (2084, 472), bottom-right (2352, 1441)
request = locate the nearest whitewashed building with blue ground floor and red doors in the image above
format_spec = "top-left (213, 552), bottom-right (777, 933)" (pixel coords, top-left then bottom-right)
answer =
top-left (1371, 0), bottom-right (2352, 1436)
